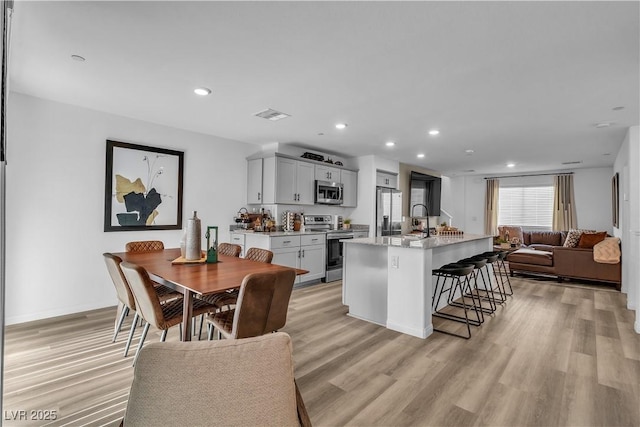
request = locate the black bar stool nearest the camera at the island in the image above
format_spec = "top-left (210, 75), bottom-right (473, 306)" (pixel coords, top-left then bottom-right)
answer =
top-left (432, 264), bottom-right (482, 339)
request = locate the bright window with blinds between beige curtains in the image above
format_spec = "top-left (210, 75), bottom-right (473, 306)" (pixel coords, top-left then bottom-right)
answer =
top-left (498, 185), bottom-right (553, 230)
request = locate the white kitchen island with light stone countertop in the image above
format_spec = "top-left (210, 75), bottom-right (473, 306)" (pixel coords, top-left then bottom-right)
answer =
top-left (342, 234), bottom-right (493, 338)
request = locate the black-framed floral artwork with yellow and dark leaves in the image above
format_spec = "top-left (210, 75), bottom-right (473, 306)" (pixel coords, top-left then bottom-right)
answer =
top-left (104, 140), bottom-right (184, 232)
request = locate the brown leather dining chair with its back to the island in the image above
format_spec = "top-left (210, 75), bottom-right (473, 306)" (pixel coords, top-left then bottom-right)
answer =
top-left (207, 269), bottom-right (296, 339)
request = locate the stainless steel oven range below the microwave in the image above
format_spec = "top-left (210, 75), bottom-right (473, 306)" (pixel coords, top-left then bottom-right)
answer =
top-left (304, 215), bottom-right (353, 282)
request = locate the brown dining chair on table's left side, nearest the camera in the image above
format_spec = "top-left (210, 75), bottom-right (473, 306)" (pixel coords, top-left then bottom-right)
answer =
top-left (120, 262), bottom-right (216, 366)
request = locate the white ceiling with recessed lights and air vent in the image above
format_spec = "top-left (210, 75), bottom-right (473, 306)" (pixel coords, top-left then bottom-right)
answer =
top-left (10, 1), bottom-right (640, 176)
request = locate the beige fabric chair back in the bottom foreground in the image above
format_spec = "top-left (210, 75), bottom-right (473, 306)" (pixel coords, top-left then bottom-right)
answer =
top-left (122, 332), bottom-right (311, 426)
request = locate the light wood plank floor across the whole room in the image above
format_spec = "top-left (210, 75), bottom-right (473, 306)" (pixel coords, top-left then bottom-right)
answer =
top-left (3, 278), bottom-right (640, 426)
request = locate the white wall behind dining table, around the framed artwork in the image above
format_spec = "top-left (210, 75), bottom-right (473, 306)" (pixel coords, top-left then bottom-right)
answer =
top-left (5, 93), bottom-right (258, 324)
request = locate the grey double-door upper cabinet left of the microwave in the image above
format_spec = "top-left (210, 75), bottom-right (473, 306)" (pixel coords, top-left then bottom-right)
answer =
top-left (262, 157), bottom-right (315, 205)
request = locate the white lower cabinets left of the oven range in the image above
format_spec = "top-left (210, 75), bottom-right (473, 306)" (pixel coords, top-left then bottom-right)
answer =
top-left (245, 234), bottom-right (326, 283)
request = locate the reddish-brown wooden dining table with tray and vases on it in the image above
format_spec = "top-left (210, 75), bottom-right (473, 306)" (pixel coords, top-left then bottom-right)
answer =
top-left (114, 248), bottom-right (308, 341)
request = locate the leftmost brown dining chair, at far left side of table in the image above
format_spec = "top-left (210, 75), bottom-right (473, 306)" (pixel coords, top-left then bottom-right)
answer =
top-left (102, 252), bottom-right (182, 357)
